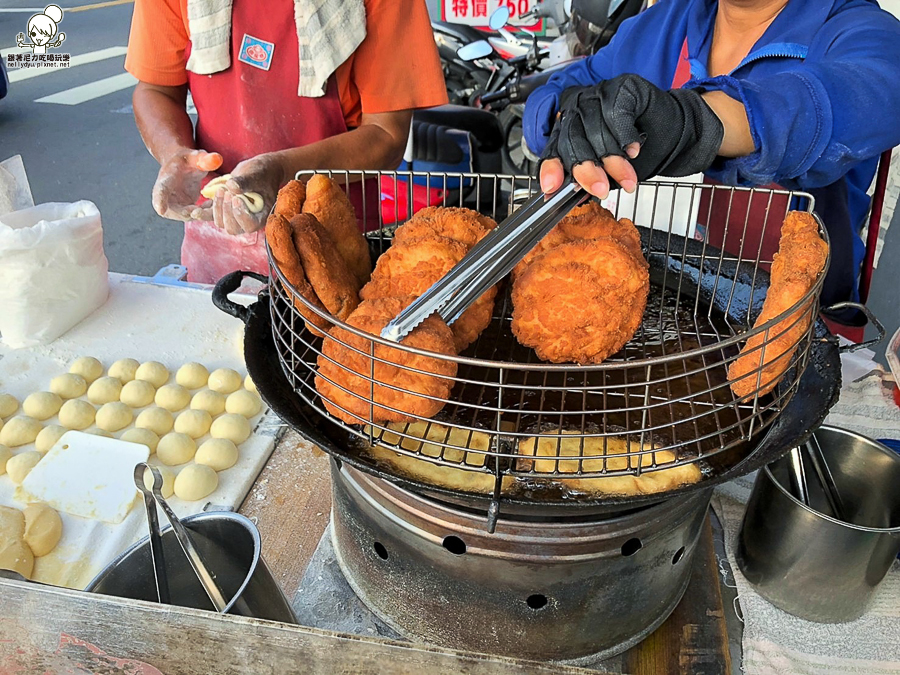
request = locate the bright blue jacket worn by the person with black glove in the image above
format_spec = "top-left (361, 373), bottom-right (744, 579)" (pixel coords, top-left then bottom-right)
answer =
top-left (524, 0), bottom-right (900, 303)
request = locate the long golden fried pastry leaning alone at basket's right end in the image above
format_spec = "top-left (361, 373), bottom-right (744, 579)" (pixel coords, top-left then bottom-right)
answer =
top-left (728, 211), bottom-right (828, 397)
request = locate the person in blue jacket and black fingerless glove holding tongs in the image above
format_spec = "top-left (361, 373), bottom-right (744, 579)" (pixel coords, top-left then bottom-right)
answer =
top-left (523, 0), bottom-right (900, 321)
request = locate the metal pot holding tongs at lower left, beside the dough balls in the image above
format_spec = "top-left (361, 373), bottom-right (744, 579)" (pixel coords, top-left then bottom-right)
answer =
top-left (85, 511), bottom-right (297, 623)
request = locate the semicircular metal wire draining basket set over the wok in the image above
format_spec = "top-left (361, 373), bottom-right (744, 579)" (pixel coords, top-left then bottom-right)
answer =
top-left (269, 171), bottom-right (830, 492)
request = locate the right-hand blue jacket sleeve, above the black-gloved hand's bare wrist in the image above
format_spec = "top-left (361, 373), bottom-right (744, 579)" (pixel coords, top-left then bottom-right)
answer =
top-left (689, 10), bottom-right (900, 189)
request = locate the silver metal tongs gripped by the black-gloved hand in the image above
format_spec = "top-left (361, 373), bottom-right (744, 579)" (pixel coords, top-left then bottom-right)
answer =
top-left (381, 180), bottom-right (590, 342)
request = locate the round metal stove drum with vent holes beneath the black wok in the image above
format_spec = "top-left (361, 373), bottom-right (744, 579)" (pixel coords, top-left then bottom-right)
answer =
top-left (332, 463), bottom-right (711, 662)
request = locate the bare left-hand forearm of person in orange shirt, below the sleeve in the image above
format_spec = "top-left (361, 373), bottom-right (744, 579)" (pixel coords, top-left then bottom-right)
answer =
top-left (132, 82), bottom-right (194, 164)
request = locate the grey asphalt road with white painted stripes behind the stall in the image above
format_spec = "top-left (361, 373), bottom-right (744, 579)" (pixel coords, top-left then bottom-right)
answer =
top-left (0, 0), bottom-right (900, 364)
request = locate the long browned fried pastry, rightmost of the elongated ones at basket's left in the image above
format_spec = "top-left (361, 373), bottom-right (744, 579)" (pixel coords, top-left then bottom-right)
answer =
top-left (303, 174), bottom-right (372, 285)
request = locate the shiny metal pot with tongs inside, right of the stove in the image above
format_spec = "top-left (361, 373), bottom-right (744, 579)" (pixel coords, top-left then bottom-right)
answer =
top-left (736, 426), bottom-right (900, 623)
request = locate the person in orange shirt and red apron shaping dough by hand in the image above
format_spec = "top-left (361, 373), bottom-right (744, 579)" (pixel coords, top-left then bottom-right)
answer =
top-left (125, 0), bottom-right (447, 283)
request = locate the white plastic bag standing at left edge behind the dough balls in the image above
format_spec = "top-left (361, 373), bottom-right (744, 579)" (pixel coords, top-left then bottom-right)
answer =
top-left (0, 201), bottom-right (109, 349)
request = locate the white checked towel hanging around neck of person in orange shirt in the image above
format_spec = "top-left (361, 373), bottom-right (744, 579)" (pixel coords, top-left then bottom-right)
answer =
top-left (187, 0), bottom-right (366, 98)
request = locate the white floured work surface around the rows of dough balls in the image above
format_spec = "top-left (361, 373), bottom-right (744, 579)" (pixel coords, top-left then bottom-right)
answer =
top-left (0, 274), bottom-right (282, 589)
